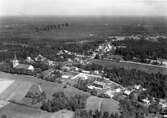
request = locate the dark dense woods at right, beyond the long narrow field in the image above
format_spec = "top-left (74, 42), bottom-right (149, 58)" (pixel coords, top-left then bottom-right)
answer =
top-left (114, 37), bottom-right (167, 62)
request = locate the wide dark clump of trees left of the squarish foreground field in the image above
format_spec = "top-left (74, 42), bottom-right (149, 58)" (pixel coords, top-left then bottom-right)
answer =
top-left (41, 92), bottom-right (88, 112)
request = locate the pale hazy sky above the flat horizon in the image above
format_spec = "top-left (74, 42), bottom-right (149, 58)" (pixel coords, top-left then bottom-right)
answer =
top-left (0, 0), bottom-right (167, 16)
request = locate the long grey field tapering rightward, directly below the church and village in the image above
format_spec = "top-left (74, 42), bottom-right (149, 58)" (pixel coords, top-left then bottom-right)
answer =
top-left (0, 72), bottom-right (89, 98)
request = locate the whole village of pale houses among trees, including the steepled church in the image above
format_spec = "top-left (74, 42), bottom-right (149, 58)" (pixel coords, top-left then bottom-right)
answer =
top-left (1, 36), bottom-right (167, 118)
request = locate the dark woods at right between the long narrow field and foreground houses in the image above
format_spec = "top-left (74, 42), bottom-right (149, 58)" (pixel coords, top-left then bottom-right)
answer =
top-left (103, 68), bottom-right (167, 98)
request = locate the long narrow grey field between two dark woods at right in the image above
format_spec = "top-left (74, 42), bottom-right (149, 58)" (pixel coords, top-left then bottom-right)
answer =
top-left (92, 60), bottom-right (167, 75)
